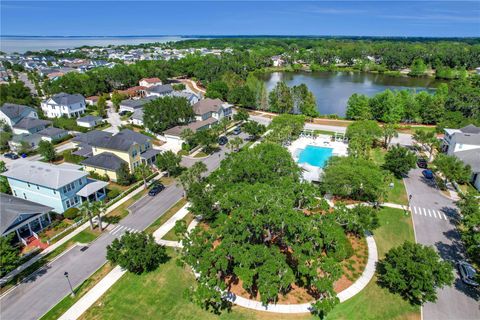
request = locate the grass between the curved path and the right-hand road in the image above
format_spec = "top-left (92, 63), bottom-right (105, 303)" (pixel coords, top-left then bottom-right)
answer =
top-left (327, 208), bottom-right (420, 320)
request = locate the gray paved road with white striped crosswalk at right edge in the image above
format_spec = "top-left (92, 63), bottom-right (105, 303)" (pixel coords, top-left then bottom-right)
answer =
top-left (405, 169), bottom-right (480, 320)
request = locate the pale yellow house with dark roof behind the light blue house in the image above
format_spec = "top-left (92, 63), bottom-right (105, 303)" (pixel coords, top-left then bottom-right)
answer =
top-left (81, 129), bottom-right (160, 181)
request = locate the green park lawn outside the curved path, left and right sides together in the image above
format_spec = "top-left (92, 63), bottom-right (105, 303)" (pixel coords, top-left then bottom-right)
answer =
top-left (81, 208), bottom-right (420, 320)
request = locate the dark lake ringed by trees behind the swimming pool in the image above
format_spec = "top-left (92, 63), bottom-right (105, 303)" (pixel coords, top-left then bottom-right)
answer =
top-left (260, 72), bottom-right (442, 116)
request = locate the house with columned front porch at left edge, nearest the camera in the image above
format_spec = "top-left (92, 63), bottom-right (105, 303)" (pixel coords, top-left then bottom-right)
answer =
top-left (0, 193), bottom-right (53, 245)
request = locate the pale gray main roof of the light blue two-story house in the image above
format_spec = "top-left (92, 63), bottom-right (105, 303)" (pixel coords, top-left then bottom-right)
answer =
top-left (2, 161), bottom-right (87, 189)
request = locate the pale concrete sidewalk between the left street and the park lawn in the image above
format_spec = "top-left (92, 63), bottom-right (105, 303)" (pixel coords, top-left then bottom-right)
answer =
top-left (59, 202), bottom-right (189, 320)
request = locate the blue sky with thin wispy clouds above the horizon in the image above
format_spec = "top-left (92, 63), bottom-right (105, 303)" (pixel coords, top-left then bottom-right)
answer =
top-left (0, 0), bottom-right (480, 37)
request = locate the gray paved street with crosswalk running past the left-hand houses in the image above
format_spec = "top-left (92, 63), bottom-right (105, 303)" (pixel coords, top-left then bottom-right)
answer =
top-left (0, 137), bottom-right (246, 320)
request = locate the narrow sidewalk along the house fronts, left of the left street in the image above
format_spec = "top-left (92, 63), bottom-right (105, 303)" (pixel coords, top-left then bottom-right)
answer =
top-left (0, 172), bottom-right (163, 285)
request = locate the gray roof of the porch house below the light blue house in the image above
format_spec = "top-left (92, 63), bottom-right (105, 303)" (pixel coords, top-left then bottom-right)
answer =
top-left (0, 193), bottom-right (53, 235)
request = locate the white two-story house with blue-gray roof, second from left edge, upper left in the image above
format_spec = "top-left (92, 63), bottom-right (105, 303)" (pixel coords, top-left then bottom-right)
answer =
top-left (41, 93), bottom-right (86, 118)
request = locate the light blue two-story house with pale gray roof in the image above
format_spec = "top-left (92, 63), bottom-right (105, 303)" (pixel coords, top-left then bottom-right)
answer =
top-left (2, 161), bottom-right (107, 213)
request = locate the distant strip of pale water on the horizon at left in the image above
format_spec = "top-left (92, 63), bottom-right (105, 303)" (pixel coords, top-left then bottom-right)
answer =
top-left (0, 36), bottom-right (188, 53)
